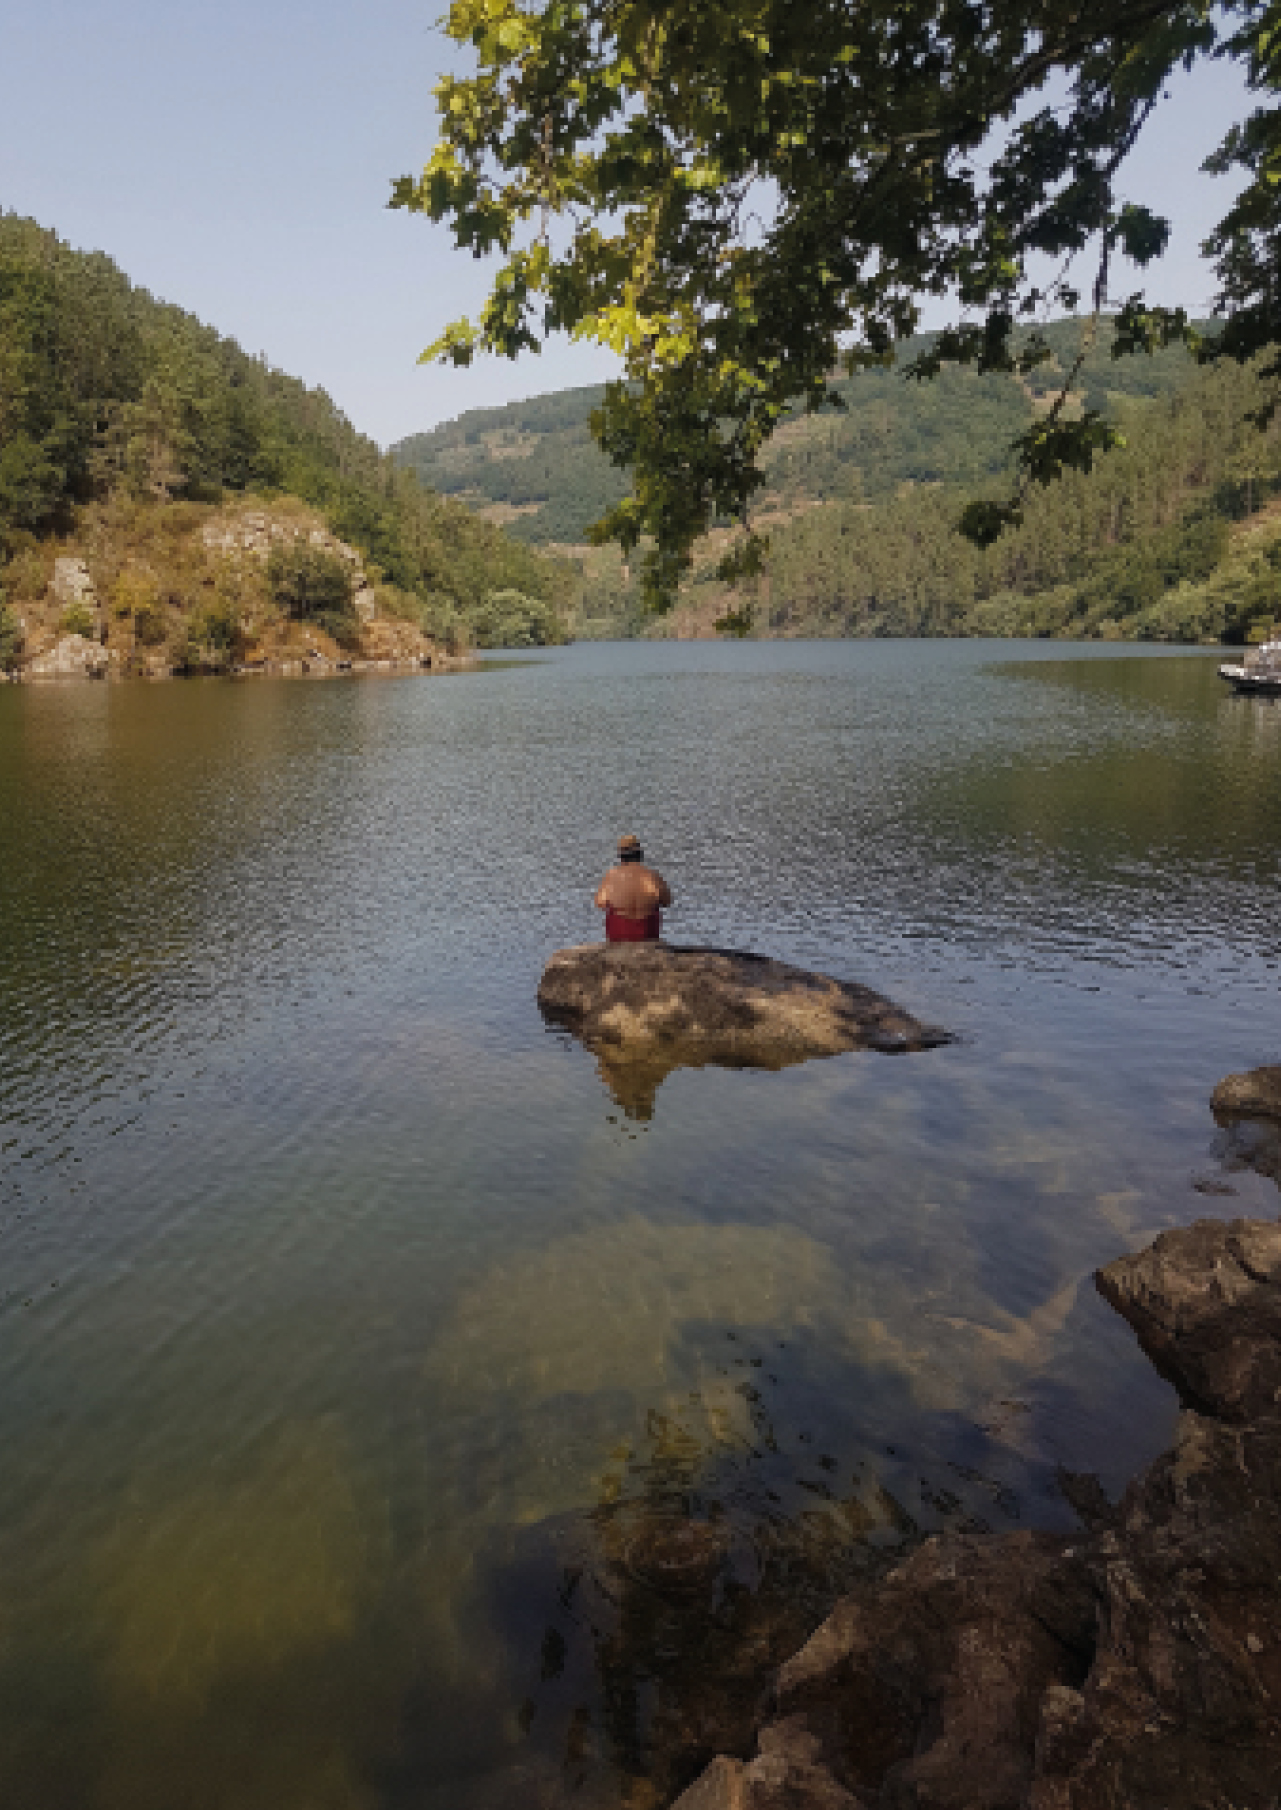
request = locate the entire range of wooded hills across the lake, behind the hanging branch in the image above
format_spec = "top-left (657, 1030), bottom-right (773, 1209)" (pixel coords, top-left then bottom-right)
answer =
top-left (393, 320), bottom-right (1281, 641)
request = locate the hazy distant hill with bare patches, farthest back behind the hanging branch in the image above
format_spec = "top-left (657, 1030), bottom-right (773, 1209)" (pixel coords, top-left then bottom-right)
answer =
top-left (391, 320), bottom-right (1192, 545)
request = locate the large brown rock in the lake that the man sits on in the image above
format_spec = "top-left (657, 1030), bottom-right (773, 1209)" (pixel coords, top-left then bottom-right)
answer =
top-left (537, 943), bottom-right (950, 1117)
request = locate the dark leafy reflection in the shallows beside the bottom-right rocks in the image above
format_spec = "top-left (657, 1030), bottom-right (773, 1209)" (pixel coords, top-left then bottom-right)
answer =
top-left (506, 1356), bottom-right (917, 1810)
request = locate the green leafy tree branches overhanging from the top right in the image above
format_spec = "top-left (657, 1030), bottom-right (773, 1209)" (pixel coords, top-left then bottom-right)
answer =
top-left (393, 0), bottom-right (1281, 605)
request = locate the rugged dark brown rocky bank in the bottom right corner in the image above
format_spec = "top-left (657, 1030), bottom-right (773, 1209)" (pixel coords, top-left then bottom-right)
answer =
top-left (678, 1220), bottom-right (1281, 1810)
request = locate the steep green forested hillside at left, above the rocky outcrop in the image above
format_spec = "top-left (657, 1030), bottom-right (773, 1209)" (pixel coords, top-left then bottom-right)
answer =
top-left (0, 214), bottom-right (568, 666)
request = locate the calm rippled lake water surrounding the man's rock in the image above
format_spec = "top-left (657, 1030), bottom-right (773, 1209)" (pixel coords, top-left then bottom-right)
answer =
top-left (0, 643), bottom-right (1281, 1810)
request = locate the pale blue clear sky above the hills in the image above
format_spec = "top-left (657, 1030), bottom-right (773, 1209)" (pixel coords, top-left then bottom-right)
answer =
top-left (0, 0), bottom-right (1247, 445)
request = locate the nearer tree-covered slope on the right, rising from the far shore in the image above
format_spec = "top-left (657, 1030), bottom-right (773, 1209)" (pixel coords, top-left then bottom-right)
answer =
top-left (702, 352), bottom-right (1281, 641)
